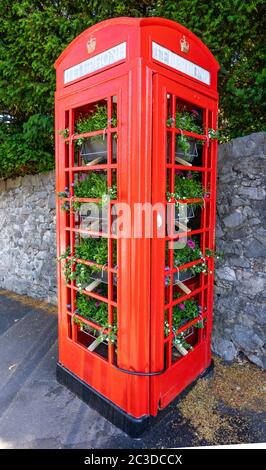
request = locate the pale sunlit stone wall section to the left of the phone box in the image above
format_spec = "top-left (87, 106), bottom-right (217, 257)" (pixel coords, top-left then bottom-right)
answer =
top-left (0, 172), bottom-right (56, 303)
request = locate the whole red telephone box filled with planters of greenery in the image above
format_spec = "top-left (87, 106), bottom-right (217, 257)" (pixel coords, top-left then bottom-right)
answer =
top-left (55, 18), bottom-right (219, 436)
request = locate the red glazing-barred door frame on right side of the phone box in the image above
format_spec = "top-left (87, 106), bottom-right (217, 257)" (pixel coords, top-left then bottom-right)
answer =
top-left (150, 75), bottom-right (217, 415)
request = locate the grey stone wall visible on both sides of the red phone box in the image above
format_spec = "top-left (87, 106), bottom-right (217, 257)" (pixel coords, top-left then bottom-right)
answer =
top-left (0, 133), bottom-right (266, 368)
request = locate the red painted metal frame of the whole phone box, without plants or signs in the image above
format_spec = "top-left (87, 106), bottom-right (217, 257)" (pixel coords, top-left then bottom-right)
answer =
top-left (55, 18), bottom-right (219, 417)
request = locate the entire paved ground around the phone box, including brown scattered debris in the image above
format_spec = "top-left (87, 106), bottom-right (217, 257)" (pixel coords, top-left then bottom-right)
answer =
top-left (0, 290), bottom-right (266, 449)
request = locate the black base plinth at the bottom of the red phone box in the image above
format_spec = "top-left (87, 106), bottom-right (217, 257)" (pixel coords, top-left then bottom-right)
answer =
top-left (56, 361), bottom-right (214, 438)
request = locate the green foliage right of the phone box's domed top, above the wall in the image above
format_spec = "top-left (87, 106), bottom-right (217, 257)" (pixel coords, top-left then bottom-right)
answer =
top-left (154, 0), bottom-right (266, 139)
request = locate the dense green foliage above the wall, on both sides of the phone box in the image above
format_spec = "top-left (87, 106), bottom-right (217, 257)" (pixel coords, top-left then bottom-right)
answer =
top-left (0, 0), bottom-right (266, 177)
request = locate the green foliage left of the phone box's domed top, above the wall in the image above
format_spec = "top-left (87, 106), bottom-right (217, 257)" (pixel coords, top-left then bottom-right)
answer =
top-left (0, 0), bottom-right (148, 178)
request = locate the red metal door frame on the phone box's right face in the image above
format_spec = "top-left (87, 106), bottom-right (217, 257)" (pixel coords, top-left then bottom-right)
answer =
top-left (150, 75), bottom-right (217, 415)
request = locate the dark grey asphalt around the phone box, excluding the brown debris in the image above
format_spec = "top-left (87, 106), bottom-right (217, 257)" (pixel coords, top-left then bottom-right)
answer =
top-left (0, 290), bottom-right (266, 449)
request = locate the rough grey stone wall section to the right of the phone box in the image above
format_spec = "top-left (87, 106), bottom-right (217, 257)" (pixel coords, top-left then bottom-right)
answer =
top-left (213, 132), bottom-right (266, 368)
